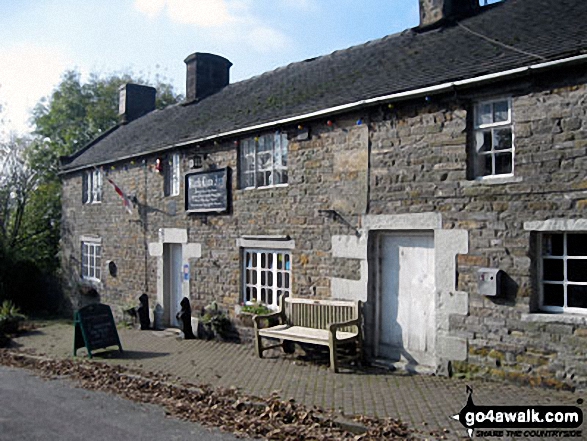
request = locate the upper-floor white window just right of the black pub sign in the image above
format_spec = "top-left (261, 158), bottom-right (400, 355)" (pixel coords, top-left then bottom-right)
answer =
top-left (239, 132), bottom-right (288, 188)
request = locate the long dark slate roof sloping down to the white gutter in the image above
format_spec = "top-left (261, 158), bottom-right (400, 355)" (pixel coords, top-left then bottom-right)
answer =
top-left (63, 0), bottom-right (587, 172)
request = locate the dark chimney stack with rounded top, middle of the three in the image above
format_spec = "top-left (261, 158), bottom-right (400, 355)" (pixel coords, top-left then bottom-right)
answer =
top-left (185, 52), bottom-right (232, 103)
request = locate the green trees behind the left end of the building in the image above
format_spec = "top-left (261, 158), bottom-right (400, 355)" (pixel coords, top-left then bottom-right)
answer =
top-left (0, 70), bottom-right (182, 310)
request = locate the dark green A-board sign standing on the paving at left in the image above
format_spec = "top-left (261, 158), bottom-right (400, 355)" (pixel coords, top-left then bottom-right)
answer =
top-left (73, 303), bottom-right (122, 358)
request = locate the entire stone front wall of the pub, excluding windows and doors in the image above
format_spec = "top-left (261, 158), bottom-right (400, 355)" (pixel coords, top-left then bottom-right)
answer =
top-left (62, 65), bottom-right (587, 387)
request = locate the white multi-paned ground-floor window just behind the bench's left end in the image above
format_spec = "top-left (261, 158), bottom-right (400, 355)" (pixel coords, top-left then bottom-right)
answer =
top-left (243, 249), bottom-right (291, 309)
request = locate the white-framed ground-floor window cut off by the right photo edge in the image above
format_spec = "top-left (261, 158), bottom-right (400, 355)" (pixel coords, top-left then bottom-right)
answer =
top-left (539, 232), bottom-right (587, 314)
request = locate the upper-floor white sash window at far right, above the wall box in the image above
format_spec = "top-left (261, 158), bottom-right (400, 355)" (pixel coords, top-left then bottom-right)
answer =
top-left (473, 98), bottom-right (514, 178)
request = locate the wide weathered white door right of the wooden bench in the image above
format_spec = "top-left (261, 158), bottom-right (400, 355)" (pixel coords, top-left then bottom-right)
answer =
top-left (377, 233), bottom-right (436, 366)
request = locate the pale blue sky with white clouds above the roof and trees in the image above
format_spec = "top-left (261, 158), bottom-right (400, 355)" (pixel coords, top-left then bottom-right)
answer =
top-left (0, 0), bottom-right (428, 139)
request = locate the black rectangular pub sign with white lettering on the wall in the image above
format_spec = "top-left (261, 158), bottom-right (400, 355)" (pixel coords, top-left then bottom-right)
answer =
top-left (185, 167), bottom-right (229, 213)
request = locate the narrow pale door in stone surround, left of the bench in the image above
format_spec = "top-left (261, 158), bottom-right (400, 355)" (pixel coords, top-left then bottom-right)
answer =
top-left (163, 243), bottom-right (183, 327)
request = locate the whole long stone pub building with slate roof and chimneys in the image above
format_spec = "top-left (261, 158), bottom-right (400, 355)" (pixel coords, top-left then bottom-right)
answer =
top-left (61, 0), bottom-right (587, 387)
